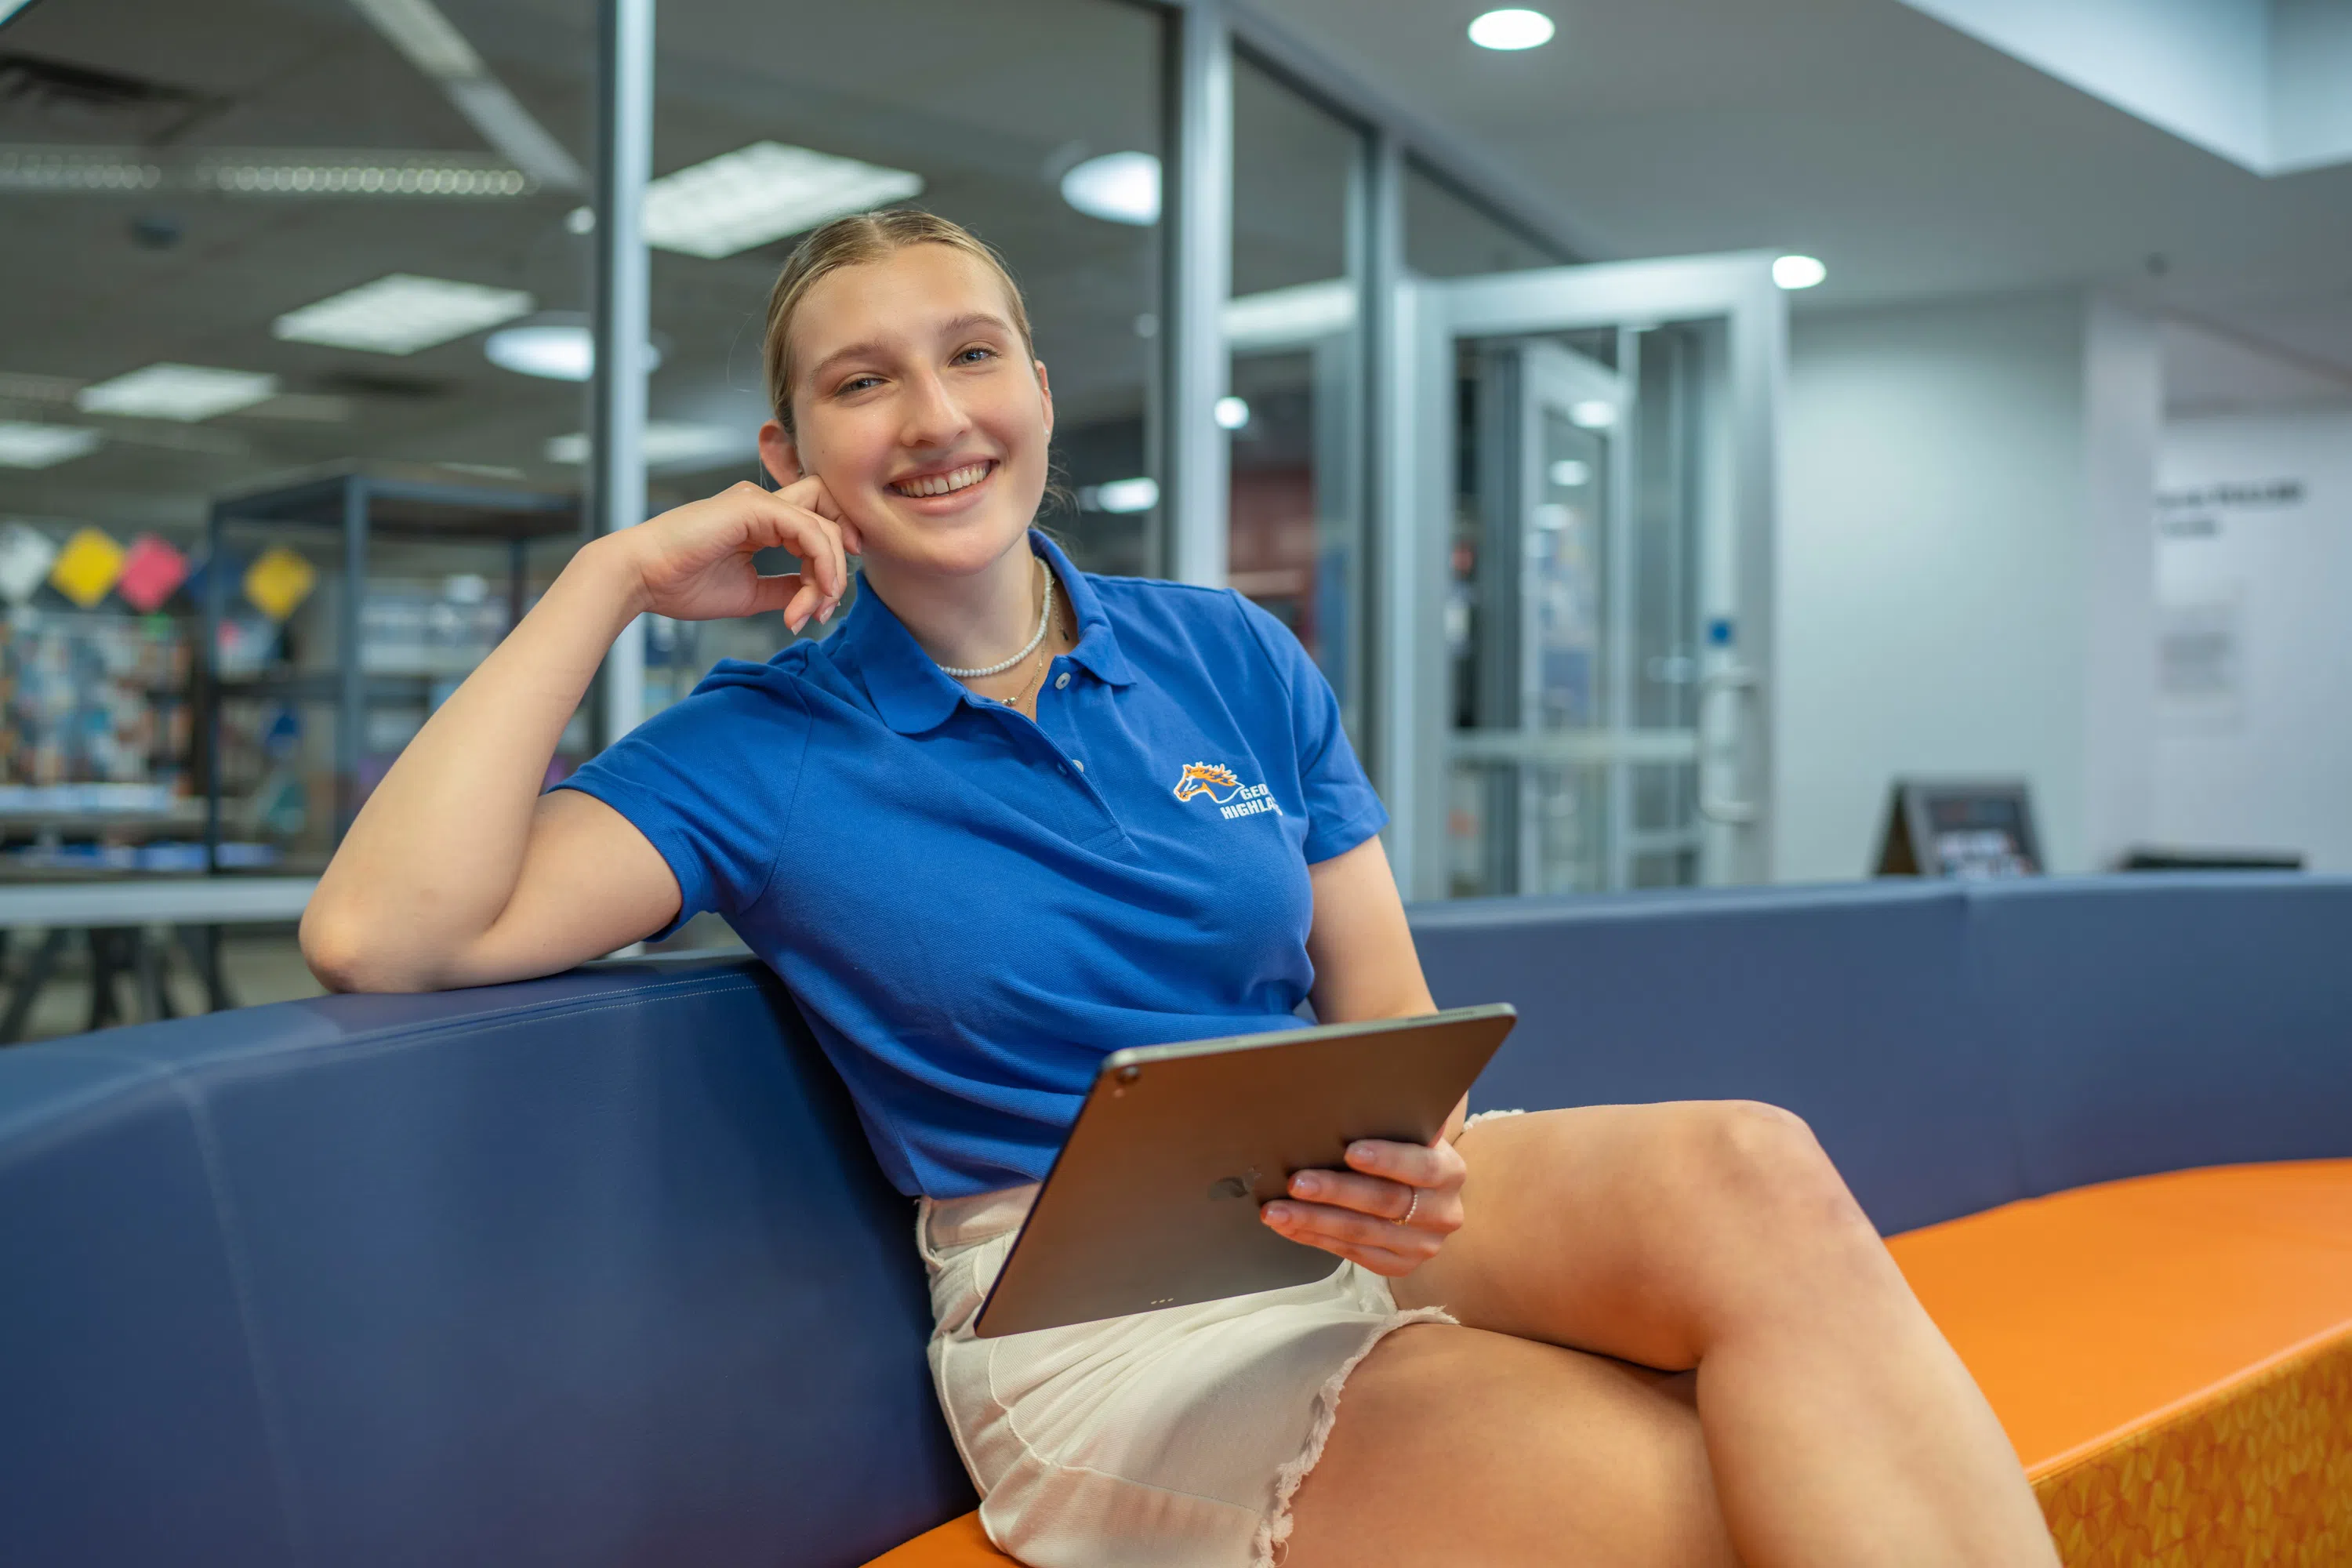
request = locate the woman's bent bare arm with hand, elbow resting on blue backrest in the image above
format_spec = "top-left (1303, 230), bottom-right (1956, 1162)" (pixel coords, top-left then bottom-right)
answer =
top-left (301, 480), bottom-right (849, 989)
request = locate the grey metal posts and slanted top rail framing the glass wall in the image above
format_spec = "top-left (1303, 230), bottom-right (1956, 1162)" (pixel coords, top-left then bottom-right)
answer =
top-left (588, 0), bottom-right (1606, 822)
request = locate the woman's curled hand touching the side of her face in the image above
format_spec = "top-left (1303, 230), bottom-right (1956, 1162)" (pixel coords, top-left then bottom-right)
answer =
top-left (614, 475), bottom-right (858, 633)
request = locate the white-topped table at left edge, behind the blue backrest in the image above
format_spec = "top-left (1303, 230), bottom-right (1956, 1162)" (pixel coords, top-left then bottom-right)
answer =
top-left (0, 877), bottom-right (318, 1046)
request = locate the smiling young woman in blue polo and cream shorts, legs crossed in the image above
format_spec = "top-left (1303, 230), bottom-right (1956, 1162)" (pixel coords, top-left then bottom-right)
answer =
top-left (303, 212), bottom-right (2056, 1568)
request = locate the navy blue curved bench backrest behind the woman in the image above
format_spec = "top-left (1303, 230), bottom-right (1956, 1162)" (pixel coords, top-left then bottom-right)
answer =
top-left (0, 877), bottom-right (2352, 1568)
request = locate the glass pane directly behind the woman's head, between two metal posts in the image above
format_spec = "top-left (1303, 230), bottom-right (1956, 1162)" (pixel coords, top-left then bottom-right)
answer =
top-left (647, 0), bottom-right (1167, 710)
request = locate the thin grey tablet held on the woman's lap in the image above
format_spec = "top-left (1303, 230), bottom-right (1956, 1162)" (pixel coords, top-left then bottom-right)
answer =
top-left (974, 1004), bottom-right (1517, 1340)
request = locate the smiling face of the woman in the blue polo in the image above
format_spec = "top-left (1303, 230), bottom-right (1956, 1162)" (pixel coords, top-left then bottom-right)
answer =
top-left (760, 245), bottom-right (1054, 576)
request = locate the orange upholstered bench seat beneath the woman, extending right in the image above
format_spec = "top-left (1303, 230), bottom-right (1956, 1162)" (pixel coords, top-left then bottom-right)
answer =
top-left (870, 1159), bottom-right (2352, 1568)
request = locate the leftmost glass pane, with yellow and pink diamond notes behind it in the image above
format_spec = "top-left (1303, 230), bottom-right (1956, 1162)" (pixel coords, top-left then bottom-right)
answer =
top-left (0, 0), bottom-right (595, 881)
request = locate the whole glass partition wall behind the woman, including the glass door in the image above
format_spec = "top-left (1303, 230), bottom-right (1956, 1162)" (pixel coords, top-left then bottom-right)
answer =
top-left (0, 0), bottom-right (1769, 895)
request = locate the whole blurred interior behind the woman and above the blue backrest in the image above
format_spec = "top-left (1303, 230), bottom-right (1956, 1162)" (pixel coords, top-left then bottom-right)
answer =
top-left (0, 0), bottom-right (2352, 1041)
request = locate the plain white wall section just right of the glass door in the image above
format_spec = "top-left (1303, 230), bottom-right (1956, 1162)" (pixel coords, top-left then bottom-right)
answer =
top-left (1773, 292), bottom-right (2159, 881)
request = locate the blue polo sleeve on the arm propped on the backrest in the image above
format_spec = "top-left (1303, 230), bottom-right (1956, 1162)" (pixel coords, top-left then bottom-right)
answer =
top-left (555, 661), bottom-right (809, 940)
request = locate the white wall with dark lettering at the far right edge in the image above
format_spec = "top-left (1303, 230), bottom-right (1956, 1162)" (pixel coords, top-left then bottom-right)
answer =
top-left (2154, 409), bottom-right (2352, 872)
